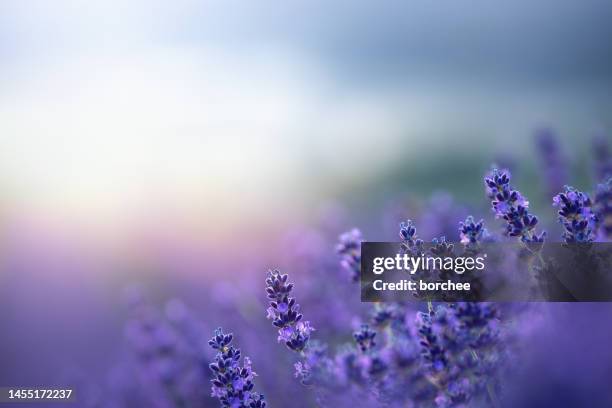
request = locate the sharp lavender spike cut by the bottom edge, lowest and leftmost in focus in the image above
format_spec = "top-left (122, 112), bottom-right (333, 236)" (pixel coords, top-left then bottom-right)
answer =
top-left (208, 328), bottom-right (266, 408)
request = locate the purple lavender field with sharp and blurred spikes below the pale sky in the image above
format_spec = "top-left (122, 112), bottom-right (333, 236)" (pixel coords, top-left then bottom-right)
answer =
top-left (1, 130), bottom-right (612, 407)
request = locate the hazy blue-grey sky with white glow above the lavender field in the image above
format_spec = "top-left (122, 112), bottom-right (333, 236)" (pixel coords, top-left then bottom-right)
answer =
top-left (0, 0), bottom-right (612, 233)
